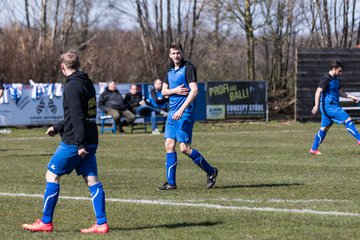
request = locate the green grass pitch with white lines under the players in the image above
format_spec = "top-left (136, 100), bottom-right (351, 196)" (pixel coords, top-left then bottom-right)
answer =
top-left (0, 122), bottom-right (360, 240)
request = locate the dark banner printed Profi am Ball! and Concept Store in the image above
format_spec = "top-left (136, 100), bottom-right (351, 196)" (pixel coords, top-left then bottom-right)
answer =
top-left (206, 81), bottom-right (267, 120)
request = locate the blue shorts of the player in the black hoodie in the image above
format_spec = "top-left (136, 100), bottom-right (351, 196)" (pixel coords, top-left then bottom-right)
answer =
top-left (48, 142), bottom-right (98, 176)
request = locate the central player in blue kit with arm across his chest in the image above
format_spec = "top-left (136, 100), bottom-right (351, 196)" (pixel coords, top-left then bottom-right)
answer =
top-left (158, 42), bottom-right (218, 190)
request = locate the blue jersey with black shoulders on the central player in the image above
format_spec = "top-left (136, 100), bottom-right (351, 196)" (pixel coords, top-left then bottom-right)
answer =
top-left (164, 60), bottom-right (197, 114)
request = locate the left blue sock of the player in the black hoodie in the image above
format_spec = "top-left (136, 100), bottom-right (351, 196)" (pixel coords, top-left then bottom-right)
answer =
top-left (41, 182), bottom-right (60, 223)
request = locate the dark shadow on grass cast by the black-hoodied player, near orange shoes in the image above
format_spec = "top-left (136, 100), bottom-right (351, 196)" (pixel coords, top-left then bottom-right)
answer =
top-left (110, 221), bottom-right (223, 231)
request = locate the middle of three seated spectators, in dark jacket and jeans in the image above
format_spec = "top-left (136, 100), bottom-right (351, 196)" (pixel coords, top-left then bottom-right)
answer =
top-left (124, 84), bottom-right (167, 134)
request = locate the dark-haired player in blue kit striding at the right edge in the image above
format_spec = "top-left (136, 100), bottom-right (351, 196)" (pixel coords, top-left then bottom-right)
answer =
top-left (310, 61), bottom-right (360, 155)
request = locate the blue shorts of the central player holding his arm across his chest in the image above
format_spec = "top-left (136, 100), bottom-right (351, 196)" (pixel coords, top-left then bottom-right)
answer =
top-left (164, 112), bottom-right (194, 144)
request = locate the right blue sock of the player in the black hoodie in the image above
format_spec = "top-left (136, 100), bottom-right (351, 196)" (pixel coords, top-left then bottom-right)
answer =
top-left (89, 182), bottom-right (107, 225)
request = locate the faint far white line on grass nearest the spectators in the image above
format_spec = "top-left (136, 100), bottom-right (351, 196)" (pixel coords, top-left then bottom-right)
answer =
top-left (0, 130), bottom-right (308, 141)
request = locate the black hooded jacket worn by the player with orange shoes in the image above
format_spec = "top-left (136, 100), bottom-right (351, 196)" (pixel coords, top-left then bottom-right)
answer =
top-left (53, 71), bottom-right (98, 149)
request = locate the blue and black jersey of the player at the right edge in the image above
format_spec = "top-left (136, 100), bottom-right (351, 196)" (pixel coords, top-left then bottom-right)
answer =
top-left (319, 74), bottom-right (340, 105)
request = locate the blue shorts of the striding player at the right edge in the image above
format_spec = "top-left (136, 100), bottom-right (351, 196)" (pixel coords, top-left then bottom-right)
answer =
top-left (320, 103), bottom-right (349, 127)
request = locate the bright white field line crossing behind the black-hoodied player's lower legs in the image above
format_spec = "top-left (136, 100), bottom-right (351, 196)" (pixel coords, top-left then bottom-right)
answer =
top-left (0, 193), bottom-right (360, 217)
